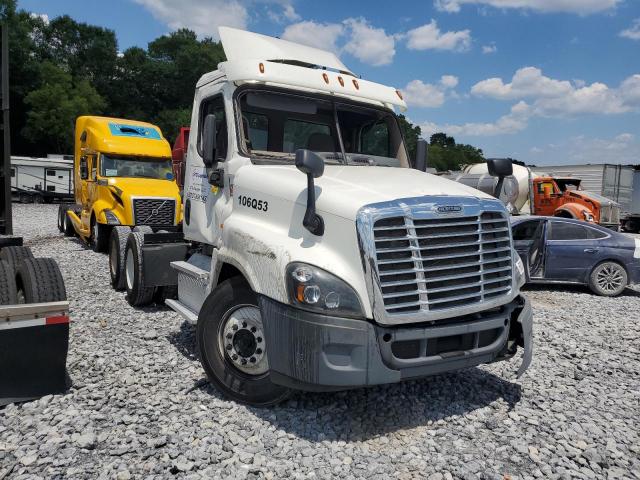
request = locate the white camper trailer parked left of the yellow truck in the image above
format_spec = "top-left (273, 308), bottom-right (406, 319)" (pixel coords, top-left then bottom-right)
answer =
top-left (11, 156), bottom-right (73, 203)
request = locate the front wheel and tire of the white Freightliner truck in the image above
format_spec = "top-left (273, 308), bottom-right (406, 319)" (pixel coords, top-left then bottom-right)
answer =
top-left (196, 277), bottom-right (291, 406)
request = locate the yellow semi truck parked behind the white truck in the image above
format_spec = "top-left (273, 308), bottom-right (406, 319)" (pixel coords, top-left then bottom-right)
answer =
top-left (59, 116), bottom-right (182, 251)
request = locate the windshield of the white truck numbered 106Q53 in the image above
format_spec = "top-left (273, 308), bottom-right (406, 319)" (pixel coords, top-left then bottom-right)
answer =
top-left (239, 91), bottom-right (409, 167)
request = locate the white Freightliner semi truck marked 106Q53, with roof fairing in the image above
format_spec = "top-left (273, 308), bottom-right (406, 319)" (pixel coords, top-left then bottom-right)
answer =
top-left (111, 28), bottom-right (532, 405)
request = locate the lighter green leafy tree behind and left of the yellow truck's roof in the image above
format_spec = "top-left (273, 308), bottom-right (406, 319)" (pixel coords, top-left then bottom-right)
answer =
top-left (22, 61), bottom-right (105, 153)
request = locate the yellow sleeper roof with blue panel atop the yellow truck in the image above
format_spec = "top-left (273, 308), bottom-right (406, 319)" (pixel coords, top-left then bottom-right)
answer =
top-left (76, 116), bottom-right (171, 157)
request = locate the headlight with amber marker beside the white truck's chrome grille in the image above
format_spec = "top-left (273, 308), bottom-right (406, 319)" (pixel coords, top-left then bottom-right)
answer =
top-left (286, 262), bottom-right (364, 318)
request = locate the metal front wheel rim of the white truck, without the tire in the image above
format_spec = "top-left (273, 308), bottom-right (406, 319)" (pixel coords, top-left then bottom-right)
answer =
top-left (218, 305), bottom-right (269, 376)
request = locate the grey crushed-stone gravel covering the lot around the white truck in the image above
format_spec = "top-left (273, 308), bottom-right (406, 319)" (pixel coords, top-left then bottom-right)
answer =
top-left (0, 205), bottom-right (640, 480)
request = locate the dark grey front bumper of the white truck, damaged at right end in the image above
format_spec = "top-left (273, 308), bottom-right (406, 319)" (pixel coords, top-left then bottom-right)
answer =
top-left (259, 296), bottom-right (533, 391)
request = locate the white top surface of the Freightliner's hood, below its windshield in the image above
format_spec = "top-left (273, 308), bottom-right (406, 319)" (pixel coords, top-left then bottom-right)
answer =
top-left (234, 165), bottom-right (493, 220)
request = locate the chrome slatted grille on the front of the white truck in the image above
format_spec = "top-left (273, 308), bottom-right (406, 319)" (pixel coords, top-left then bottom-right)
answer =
top-left (373, 212), bottom-right (512, 314)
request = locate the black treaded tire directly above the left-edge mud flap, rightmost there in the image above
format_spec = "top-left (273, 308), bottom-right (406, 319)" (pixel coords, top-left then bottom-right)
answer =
top-left (17, 258), bottom-right (67, 303)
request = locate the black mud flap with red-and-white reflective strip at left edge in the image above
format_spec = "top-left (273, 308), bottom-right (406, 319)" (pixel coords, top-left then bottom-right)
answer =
top-left (0, 301), bottom-right (70, 406)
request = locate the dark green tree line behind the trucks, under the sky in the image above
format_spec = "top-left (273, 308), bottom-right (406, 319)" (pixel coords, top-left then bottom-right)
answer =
top-left (0, 0), bottom-right (484, 170)
